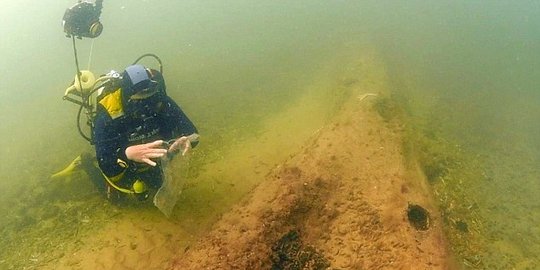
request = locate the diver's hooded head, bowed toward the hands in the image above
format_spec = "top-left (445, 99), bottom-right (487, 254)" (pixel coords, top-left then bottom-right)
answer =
top-left (122, 65), bottom-right (159, 100)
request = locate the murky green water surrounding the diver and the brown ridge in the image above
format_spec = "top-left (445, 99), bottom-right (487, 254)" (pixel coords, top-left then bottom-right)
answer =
top-left (0, 0), bottom-right (540, 269)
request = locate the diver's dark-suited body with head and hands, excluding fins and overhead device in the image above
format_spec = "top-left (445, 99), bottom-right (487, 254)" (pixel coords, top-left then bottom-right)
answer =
top-left (93, 65), bottom-right (198, 201)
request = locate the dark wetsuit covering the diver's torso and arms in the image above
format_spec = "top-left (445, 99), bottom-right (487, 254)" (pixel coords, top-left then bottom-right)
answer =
top-left (94, 75), bottom-right (198, 191)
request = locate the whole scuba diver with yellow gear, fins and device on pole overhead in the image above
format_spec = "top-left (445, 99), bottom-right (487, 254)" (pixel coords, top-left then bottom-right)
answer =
top-left (56, 0), bottom-right (199, 210)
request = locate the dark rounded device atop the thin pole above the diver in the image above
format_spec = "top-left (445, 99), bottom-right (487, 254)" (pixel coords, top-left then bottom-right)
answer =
top-left (62, 0), bottom-right (103, 39)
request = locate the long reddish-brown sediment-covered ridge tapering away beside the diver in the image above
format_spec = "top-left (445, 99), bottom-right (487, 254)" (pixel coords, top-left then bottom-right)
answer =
top-left (171, 54), bottom-right (452, 269)
